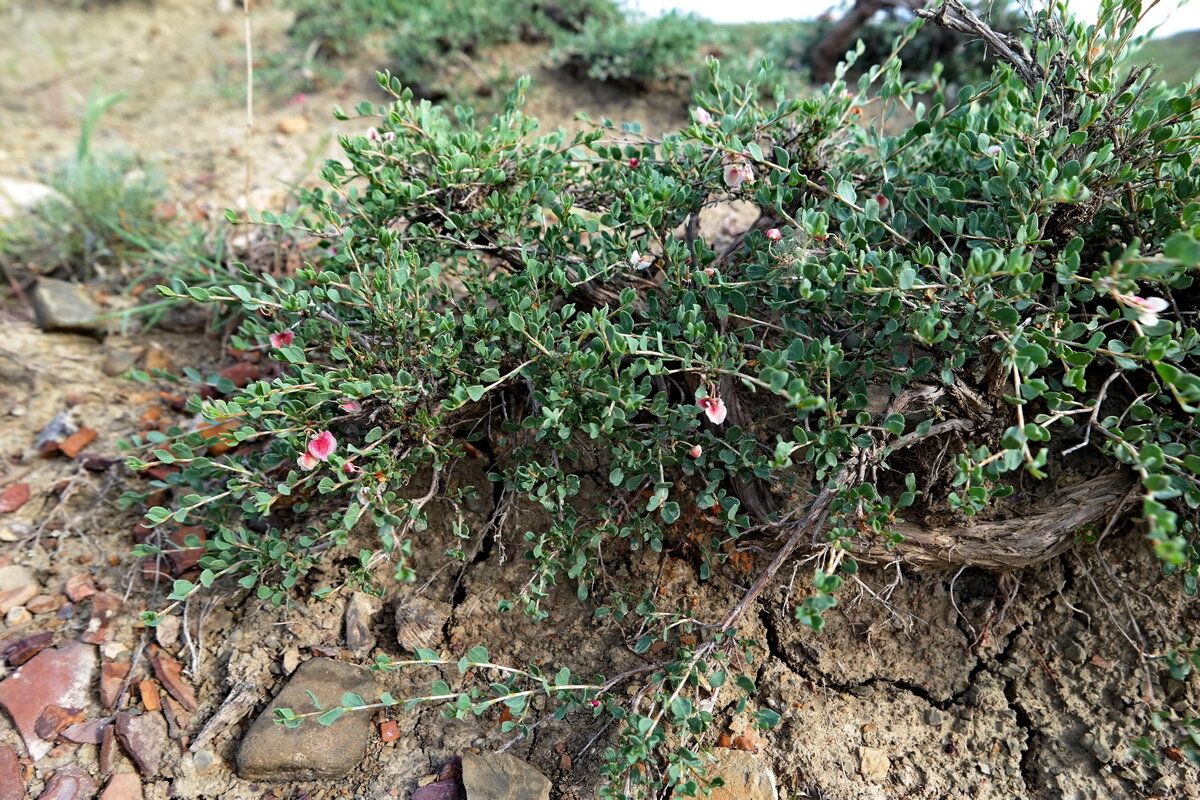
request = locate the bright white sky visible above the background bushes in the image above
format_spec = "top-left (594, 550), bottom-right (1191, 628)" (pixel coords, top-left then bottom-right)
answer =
top-left (625, 0), bottom-right (1200, 36)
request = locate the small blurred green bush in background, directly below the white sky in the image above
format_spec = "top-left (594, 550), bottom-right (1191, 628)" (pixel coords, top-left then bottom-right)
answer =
top-left (550, 12), bottom-right (713, 89)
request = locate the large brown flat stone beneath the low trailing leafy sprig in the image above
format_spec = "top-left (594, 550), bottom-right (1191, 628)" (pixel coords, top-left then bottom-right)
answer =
top-left (238, 658), bottom-right (374, 781)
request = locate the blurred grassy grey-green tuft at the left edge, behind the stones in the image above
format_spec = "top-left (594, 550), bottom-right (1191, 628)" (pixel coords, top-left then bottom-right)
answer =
top-left (0, 95), bottom-right (164, 279)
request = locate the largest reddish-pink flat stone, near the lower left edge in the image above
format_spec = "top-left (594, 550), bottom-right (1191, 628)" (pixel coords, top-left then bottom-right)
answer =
top-left (0, 642), bottom-right (96, 762)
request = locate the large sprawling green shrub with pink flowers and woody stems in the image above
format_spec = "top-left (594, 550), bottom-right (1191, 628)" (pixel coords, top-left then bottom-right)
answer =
top-left (126, 0), bottom-right (1200, 798)
